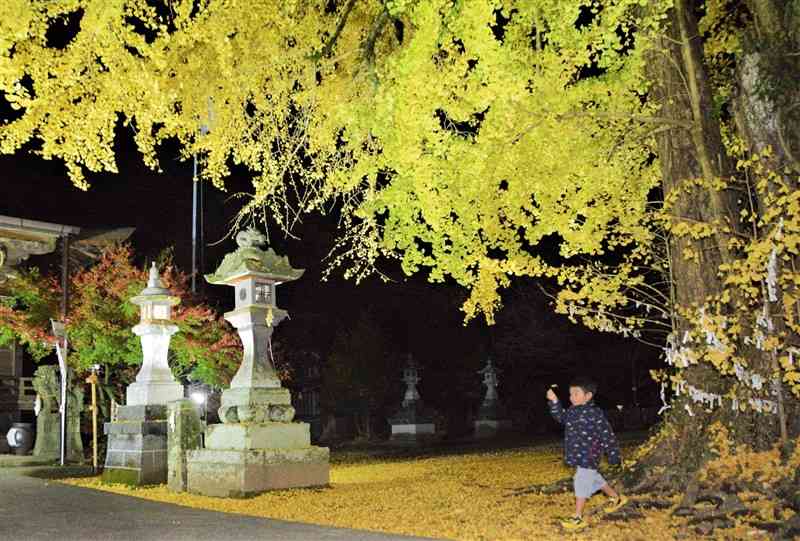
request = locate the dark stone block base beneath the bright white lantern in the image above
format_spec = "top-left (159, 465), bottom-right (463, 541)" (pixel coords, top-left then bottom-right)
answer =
top-left (103, 405), bottom-right (167, 486)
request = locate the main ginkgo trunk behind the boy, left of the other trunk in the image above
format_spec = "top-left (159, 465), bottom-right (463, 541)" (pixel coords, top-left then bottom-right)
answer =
top-left (630, 0), bottom-right (792, 490)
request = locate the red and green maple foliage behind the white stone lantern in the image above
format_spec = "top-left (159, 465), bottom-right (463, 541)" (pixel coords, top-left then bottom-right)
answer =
top-left (0, 245), bottom-right (241, 385)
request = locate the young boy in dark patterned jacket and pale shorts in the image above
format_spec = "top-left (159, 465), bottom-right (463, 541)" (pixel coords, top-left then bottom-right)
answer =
top-left (547, 378), bottom-right (628, 530)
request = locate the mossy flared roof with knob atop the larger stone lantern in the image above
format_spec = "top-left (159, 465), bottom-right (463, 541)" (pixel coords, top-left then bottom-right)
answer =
top-left (205, 229), bottom-right (305, 285)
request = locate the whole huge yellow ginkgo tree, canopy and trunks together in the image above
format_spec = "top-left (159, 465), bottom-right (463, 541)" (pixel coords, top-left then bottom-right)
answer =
top-left (0, 0), bottom-right (800, 528)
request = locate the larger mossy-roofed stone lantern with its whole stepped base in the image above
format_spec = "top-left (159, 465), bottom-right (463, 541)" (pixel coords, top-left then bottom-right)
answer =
top-left (186, 230), bottom-right (330, 497)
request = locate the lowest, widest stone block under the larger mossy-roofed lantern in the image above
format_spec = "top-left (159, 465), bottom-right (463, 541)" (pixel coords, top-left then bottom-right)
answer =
top-left (186, 438), bottom-right (330, 498)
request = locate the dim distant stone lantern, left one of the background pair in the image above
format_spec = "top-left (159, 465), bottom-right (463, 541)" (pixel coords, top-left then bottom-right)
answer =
top-left (388, 354), bottom-right (437, 445)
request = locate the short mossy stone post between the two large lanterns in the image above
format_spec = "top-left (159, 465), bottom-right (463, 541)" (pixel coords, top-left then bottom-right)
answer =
top-left (167, 398), bottom-right (204, 492)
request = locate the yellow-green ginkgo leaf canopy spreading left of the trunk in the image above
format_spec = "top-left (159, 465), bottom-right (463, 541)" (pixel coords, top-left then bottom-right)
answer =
top-left (0, 0), bottom-right (670, 320)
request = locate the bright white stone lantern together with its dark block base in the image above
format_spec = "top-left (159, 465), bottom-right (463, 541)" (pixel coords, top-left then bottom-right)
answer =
top-left (103, 264), bottom-right (183, 485)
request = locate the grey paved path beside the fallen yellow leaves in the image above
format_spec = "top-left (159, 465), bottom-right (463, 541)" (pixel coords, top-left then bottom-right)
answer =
top-left (0, 468), bottom-right (440, 541)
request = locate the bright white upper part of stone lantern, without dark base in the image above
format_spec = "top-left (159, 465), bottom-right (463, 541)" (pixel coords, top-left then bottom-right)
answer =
top-left (126, 263), bottom-right (183, 406)
